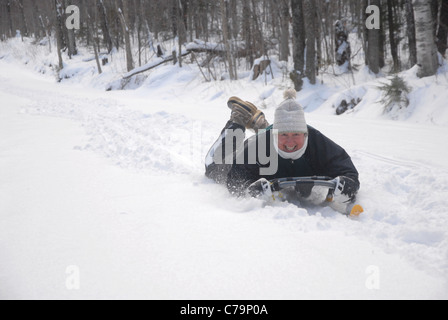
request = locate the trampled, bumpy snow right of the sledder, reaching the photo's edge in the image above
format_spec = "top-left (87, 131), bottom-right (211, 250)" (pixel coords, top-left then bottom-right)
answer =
top-left (353, 150), bottom-right (448, 277)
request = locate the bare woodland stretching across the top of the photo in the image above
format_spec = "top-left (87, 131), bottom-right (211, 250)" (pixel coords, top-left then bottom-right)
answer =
top-left (0, 0), bottom-right (448, 91)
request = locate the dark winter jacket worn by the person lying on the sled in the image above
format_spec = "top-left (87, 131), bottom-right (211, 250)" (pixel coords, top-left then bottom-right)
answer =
top-left (227, 126), bottom-right (360, 195)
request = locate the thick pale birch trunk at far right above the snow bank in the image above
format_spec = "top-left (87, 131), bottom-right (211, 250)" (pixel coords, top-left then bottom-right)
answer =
top-left (412, 0), bottom-right (439, 78)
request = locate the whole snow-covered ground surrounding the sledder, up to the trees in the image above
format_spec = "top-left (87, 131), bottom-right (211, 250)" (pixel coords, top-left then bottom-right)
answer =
top-left (0, 38), bottom-right (448, 299)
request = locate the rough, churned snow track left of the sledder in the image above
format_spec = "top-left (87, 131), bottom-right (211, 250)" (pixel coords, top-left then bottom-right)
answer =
top-left (18, 90), bottom-right (213, 174)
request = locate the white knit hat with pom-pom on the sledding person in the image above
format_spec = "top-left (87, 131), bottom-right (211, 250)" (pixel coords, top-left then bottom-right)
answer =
top-left (274, 89), bottom-right (308, 133)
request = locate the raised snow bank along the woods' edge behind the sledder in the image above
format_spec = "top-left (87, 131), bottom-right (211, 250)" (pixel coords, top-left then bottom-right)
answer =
top-left (0, 35), bottom-right (448, 126)
